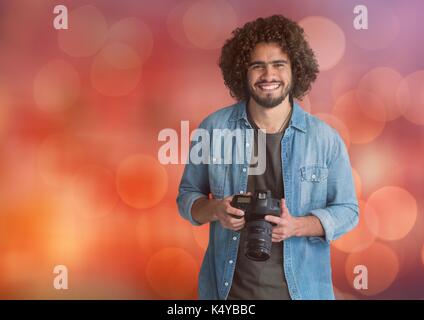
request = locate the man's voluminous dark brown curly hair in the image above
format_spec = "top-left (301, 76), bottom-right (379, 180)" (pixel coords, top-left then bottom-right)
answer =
top-left (219, 15), bottom-right (319, 101)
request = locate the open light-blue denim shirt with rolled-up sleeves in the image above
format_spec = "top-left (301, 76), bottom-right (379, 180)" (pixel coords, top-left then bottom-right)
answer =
top-left (177, 101), bottom-right (359, 299)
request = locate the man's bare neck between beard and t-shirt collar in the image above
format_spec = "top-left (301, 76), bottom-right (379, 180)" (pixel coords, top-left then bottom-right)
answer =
top-left (247, 97), bottom-right (291, 133)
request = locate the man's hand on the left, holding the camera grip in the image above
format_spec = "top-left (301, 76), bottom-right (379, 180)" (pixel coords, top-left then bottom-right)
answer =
top-left (214, 196), bottom-right (245, 231)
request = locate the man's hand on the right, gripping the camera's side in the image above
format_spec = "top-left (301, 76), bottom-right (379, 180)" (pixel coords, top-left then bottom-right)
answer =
top-left (265, 199), bottom-right (299, 242)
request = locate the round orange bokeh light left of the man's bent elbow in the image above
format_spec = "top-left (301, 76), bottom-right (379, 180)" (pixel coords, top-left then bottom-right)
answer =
top-left (116, 154), bottom-right (168, 209)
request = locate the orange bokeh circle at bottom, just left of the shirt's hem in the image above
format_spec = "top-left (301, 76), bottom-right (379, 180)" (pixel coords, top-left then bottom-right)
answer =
top-left (146, 247), bottom-right (199, 299)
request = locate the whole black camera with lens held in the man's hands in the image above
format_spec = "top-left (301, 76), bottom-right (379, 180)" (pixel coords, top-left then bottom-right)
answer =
top-left (231, 190), bottom-right (281, 261)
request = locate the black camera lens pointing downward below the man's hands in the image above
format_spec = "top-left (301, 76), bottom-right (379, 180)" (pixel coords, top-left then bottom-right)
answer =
top-left (245, 220), bottom-right (272, 261)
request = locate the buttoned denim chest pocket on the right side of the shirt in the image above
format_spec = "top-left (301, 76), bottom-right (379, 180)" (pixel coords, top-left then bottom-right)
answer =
top-left (300, 165), bottom-right (328, 210)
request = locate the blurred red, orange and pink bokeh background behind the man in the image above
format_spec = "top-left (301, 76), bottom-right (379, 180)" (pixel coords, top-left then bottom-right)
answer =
top-left (0, 0), bottom-right (424, 299)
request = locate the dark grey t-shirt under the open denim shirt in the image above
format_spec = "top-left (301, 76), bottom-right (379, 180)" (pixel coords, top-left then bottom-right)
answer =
top-left (228, 107), bottom-right (290, 300)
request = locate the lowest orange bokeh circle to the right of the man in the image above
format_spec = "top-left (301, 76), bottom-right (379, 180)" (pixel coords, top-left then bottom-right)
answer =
top-left (345, 242), bottom-right (399, 296)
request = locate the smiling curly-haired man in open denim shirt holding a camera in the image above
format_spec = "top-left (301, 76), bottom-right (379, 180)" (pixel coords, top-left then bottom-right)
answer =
top-left (177, 15), bottom-right (358, 299)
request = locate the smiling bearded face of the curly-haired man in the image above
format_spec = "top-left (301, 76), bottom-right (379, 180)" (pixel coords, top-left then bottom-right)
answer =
top-left (247, 42), bottom-right (292, 108)
